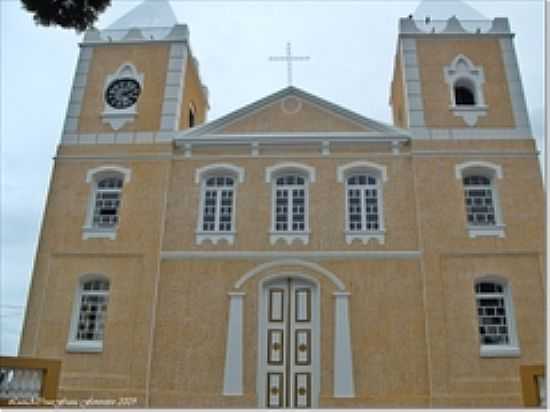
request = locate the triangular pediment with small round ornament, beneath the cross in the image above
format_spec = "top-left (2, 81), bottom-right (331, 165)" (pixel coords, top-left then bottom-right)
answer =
top-left (181, 87), bottom-right (407, 138)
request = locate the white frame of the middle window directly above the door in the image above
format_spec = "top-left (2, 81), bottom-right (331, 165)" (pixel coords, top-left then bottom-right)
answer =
top-left (265, 162), bottom-right (315, 245)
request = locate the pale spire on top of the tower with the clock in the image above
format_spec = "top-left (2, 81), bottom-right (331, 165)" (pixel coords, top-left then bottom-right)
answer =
top-left (107, 0), bottom-right (178, 30)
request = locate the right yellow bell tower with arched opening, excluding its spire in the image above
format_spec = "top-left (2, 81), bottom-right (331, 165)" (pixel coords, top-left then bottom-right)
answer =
top-left (390, 16), bottom-right (531, 139)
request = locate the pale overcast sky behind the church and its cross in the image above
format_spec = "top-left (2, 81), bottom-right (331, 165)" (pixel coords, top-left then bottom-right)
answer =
top-left (0, 0), bottom-right (544, 355)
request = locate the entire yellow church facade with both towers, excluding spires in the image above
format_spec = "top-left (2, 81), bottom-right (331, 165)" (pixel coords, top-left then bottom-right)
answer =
top-left (20, 3), bottom-right (546, 408)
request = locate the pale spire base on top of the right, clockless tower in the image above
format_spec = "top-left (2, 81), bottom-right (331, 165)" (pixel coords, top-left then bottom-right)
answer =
top-left (413, 0), bottom-right (488, 20)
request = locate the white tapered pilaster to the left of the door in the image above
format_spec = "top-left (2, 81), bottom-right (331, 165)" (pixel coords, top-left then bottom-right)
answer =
top-left (223, 292), bottom-right (245, 396)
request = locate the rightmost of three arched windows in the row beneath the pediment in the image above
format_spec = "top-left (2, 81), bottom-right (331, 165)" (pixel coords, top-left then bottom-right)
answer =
top-left (337, 162), bottom-right (387, 244)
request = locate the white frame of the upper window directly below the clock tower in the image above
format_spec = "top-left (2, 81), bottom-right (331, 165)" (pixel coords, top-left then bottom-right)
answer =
top-left (82, 165), bottom-right (131, 240)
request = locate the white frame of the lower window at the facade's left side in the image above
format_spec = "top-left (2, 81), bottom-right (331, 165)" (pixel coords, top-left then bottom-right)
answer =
top-left (66, 274), bottom-right (111, 352)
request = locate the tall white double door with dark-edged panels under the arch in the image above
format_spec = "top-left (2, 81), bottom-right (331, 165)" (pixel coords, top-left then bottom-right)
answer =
top-left (259, 278), bottom-right (319, 408)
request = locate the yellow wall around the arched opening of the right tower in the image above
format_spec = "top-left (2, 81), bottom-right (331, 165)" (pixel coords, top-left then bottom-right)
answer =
top-left (416, 38), bottom-right (515, 128)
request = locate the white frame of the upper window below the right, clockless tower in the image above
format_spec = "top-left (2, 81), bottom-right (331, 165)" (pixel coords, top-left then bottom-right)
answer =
top-left (455, 161), bottom-right (506, 238)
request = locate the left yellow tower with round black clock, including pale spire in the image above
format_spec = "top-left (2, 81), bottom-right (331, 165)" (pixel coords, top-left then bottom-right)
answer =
top-left (62, 0), bottom-right (208, 144)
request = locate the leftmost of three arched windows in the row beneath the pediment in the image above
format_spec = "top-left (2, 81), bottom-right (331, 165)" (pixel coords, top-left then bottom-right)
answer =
top-left (195, 164), bottom-right (244, 244)
